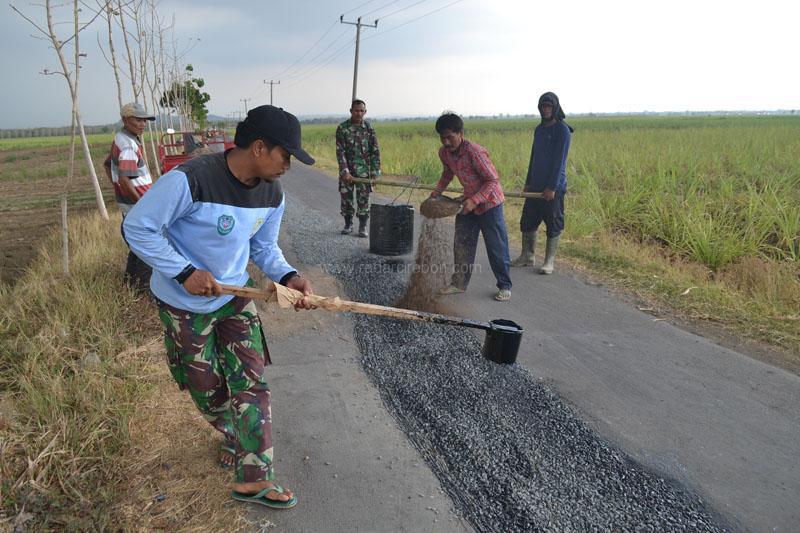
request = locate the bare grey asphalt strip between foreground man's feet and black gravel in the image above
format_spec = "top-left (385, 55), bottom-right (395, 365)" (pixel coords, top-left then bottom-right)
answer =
top-left (247, 243), bottom-right (470, 533)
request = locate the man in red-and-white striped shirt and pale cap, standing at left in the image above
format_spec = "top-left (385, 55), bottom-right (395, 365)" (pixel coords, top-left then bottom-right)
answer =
top-left (104, 102), bottom-right (156, 292)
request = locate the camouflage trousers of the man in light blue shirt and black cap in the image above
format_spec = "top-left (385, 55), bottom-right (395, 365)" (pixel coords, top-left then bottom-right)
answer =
top-left (158, 297), bottom-right (274, 483)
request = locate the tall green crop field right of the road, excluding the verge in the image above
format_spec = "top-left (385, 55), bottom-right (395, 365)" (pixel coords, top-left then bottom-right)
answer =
top-left (305, 117), bottom-right (800, 271)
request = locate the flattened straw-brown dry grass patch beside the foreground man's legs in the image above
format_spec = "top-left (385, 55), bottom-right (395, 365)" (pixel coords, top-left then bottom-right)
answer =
top-left (113, 340), bottom-right (246, 531)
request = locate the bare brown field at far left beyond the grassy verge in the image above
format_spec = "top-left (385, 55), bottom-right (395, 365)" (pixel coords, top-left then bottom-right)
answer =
top-left (0, 146), bottom-right (116, 284)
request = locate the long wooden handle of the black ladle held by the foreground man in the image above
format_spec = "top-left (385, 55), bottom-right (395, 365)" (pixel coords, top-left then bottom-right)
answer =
top-left (221, 283), bottom-right (492, 330)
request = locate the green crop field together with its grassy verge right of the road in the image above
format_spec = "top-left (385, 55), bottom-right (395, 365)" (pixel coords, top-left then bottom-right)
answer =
top-left (304, 116), bottom-right (800, 358)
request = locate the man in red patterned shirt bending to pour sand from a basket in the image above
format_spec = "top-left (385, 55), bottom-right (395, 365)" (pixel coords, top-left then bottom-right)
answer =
top-left (431, 113), bottom-right (511, 302)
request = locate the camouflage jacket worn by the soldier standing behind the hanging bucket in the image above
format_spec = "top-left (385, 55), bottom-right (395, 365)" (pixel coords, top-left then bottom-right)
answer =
top-left (336, 119), bottom-right (381, 178)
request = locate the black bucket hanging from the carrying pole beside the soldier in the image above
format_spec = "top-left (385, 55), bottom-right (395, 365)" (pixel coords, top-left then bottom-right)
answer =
top-left (369, 204), bottom-right (414, 255)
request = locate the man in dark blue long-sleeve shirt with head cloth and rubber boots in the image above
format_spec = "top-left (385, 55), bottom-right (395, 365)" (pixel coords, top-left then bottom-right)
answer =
top-left (511, 92), bottom-right (573, 274)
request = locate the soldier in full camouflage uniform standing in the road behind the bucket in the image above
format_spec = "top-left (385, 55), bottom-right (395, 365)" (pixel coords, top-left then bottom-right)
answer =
top-left (336, 100), bottom-right (381, 237)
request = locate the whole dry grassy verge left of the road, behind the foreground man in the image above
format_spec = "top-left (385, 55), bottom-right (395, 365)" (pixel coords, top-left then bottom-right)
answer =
top-left (0, 211), bottom-right (244, 531)
